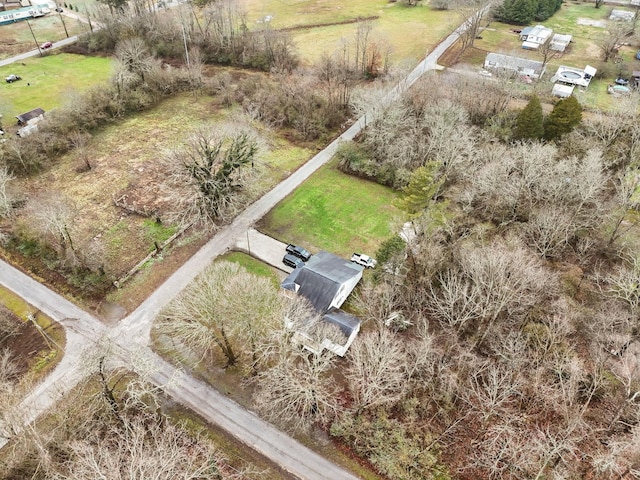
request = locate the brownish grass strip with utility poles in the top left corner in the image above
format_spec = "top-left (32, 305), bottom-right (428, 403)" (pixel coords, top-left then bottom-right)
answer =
top-left (0, 12), bottom-right (89, 60)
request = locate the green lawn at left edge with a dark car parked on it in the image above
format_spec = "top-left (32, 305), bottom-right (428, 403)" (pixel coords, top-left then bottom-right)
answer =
top-left (0, 53), bottom-right (113, 120)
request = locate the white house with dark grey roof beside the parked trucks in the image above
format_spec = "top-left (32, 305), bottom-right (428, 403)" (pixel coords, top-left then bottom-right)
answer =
top-left (280, 251), bottom-right (364, 356)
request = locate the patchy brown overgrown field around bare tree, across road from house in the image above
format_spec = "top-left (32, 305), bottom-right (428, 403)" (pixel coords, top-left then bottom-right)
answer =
top-left (6, 90), bottom-right (318, 309)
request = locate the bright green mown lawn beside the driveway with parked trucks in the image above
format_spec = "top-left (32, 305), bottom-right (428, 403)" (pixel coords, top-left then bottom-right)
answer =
top-left (260, 159), bottom-right (401, 255)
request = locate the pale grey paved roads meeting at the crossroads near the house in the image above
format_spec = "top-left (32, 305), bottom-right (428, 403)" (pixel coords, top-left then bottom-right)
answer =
top-left (0, 13), bottom-right (480, 480)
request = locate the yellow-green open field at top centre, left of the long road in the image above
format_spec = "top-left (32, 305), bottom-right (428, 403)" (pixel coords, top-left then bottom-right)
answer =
top-left (243, 0), bottom-right (460, 64)
